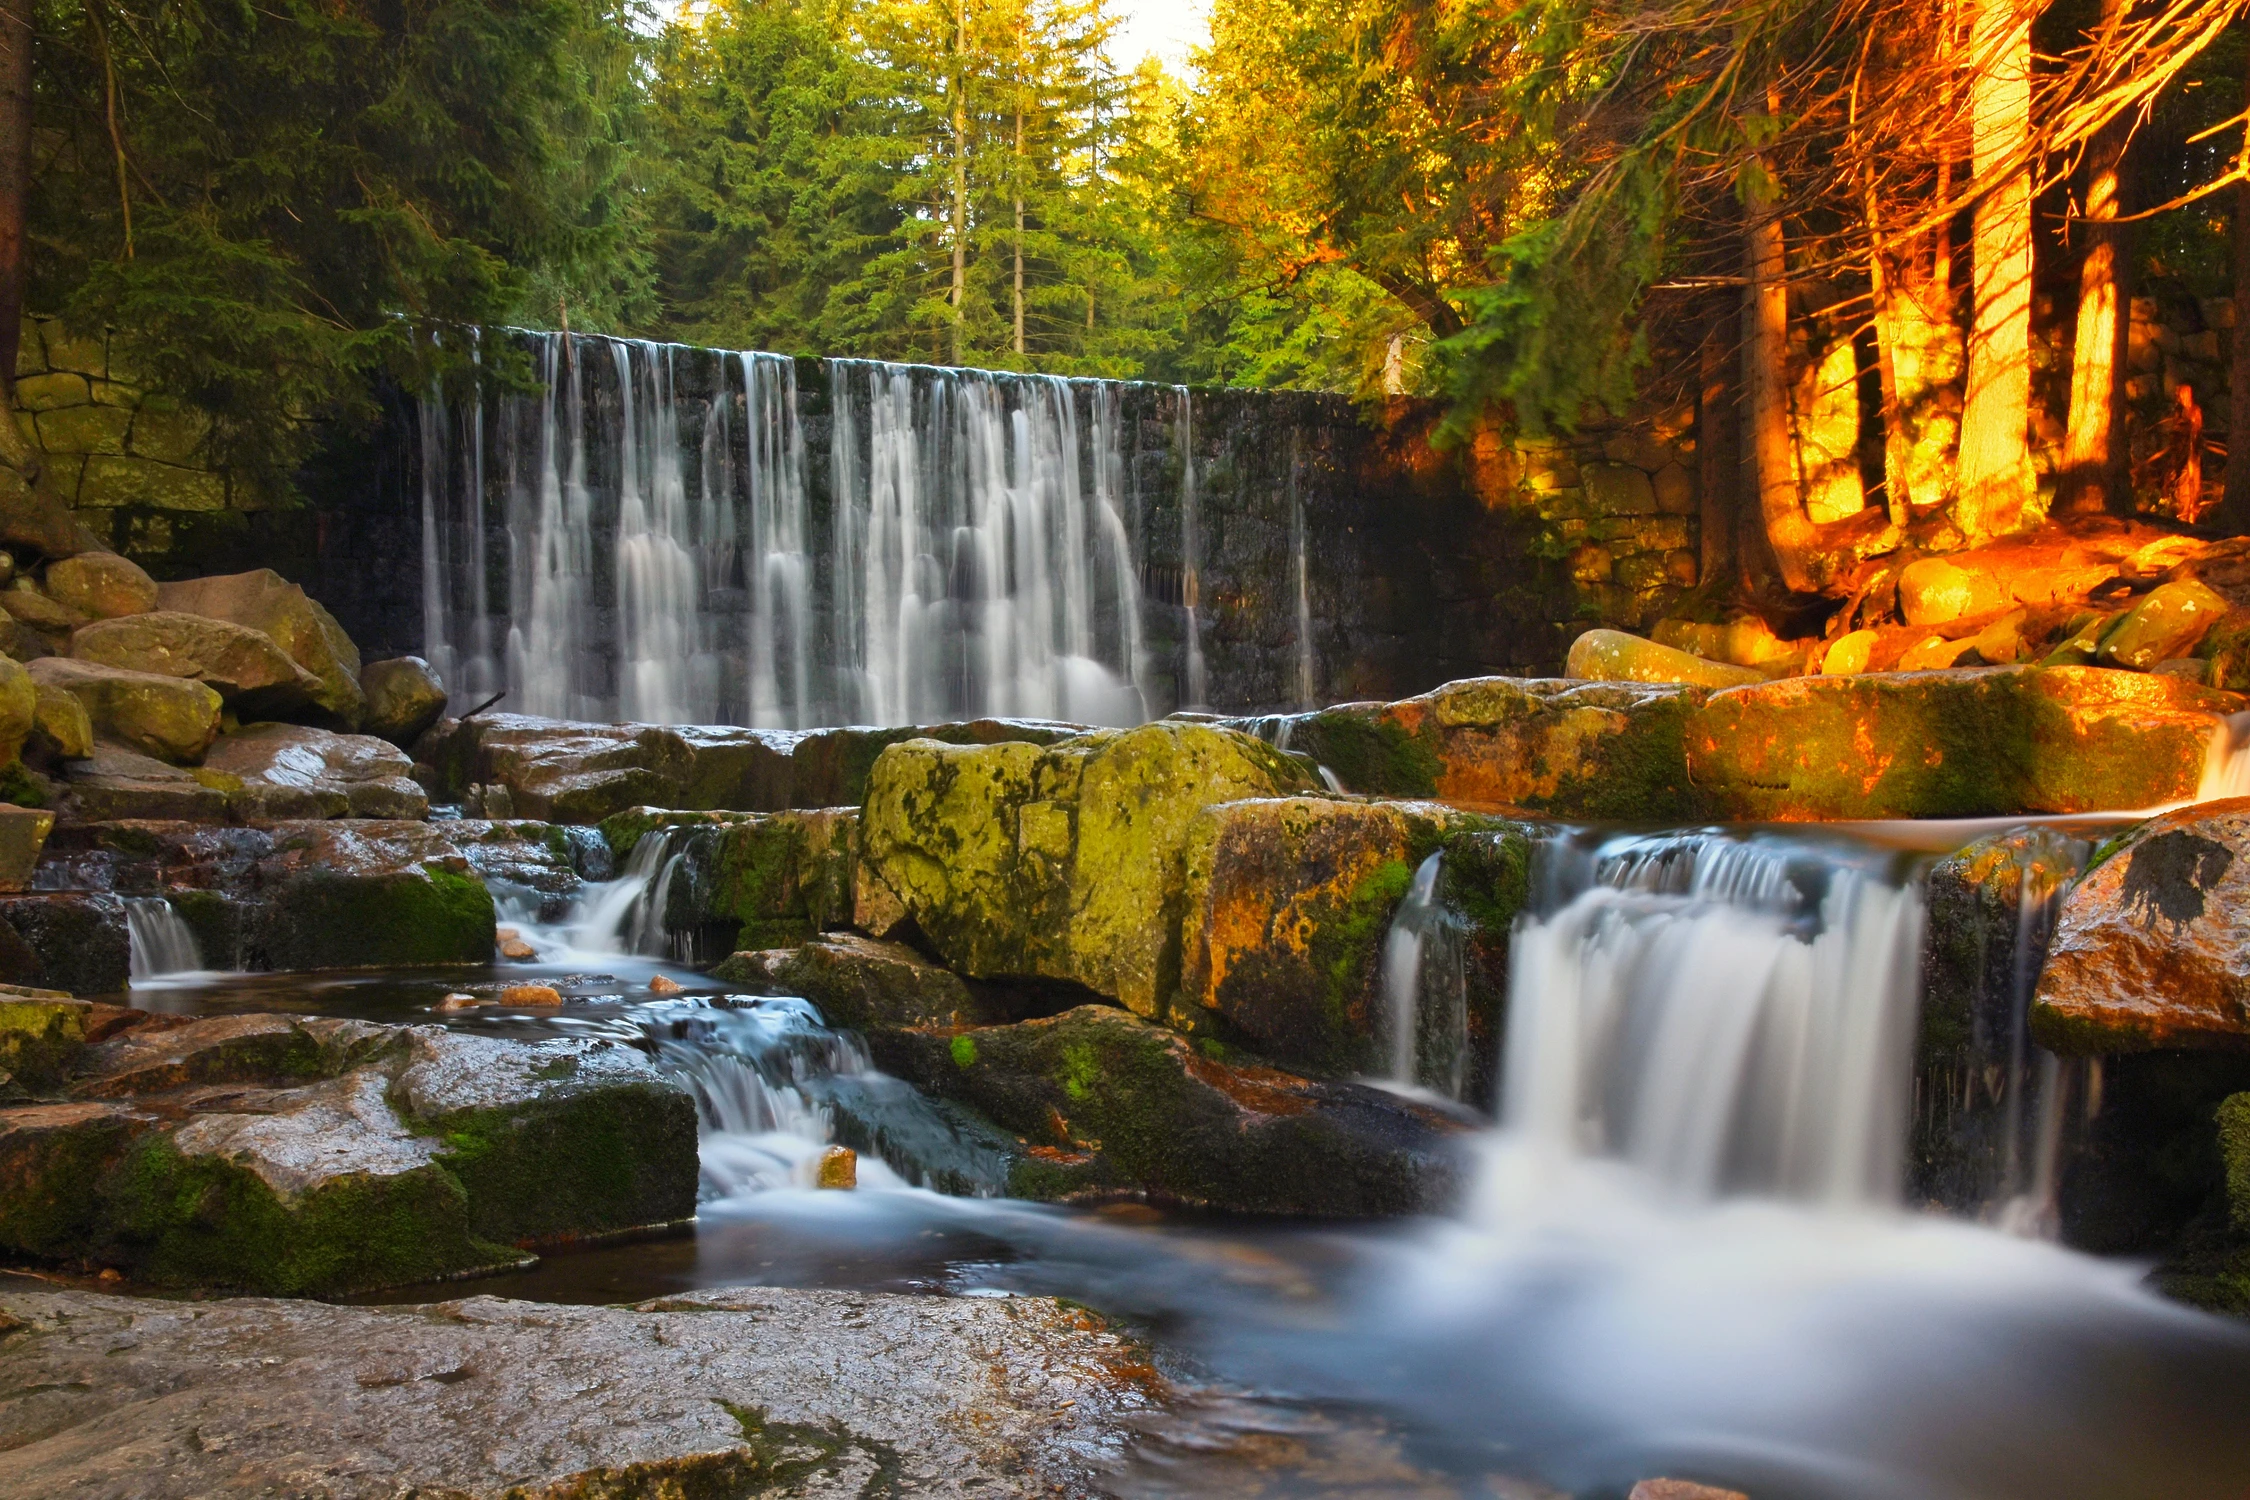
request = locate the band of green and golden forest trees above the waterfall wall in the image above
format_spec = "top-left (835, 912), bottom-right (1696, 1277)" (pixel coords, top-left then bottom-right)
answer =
top-left (13, 0), bottom-right (2250, 591)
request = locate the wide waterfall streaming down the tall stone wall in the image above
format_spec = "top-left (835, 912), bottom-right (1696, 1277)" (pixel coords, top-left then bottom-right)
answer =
top-left (419, 333), bottom-right (1148, 729)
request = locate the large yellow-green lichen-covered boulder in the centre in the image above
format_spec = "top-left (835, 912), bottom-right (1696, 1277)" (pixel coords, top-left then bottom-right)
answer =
top-left (862, 722), bottom-right (1312, 1016)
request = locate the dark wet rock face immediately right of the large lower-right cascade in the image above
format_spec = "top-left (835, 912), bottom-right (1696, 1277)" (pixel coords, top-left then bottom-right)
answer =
top-left (1906, 828), bottom-right (2093, 1214)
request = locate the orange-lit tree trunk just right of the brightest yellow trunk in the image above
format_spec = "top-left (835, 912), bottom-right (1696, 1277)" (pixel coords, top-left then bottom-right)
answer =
top-left (2054, 0), bottom-right (2124, 515)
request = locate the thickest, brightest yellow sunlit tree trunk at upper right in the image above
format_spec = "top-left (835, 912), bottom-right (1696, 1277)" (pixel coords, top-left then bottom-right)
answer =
top-left (1955, 0), bottom-right (2032, 544)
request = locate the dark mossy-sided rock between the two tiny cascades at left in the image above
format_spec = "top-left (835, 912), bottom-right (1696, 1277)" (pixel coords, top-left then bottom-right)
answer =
top-left (259, 821), bottom-right (495, 969)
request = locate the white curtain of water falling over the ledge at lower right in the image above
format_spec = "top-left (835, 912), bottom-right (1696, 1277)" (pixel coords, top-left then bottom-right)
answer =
top-left (1501, 832), bottom-right (1922, 1205)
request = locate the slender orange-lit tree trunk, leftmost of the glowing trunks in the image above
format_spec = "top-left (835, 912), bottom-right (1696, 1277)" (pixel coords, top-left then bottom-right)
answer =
top-left (1742, 149), bottom-right (1818, 594)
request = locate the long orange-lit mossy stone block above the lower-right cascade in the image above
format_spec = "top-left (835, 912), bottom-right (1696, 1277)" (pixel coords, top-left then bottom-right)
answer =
top-left (1688, 666), bottom-right (2241, 821)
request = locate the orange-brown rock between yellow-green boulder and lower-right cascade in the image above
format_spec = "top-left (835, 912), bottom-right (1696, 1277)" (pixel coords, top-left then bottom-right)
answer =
top-left (1175, 798), bottom-right (1530, 1077)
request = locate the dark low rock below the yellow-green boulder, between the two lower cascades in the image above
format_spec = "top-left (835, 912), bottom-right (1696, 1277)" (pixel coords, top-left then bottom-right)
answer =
top-left (869, 1005), bottom-right (1460, 1217)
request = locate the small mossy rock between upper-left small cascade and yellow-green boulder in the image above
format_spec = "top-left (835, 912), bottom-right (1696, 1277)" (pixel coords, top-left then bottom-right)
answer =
top-left (601, 807), bottom-right (860, 963)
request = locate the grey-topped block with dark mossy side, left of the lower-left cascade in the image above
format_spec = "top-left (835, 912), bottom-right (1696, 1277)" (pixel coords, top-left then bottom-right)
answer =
top-left (392, 1025), bottom-right (698, 1246)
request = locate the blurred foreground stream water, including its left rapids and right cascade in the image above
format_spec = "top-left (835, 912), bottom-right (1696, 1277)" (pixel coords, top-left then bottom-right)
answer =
top-left (123, 830), bottom-right (2250, 1500)
